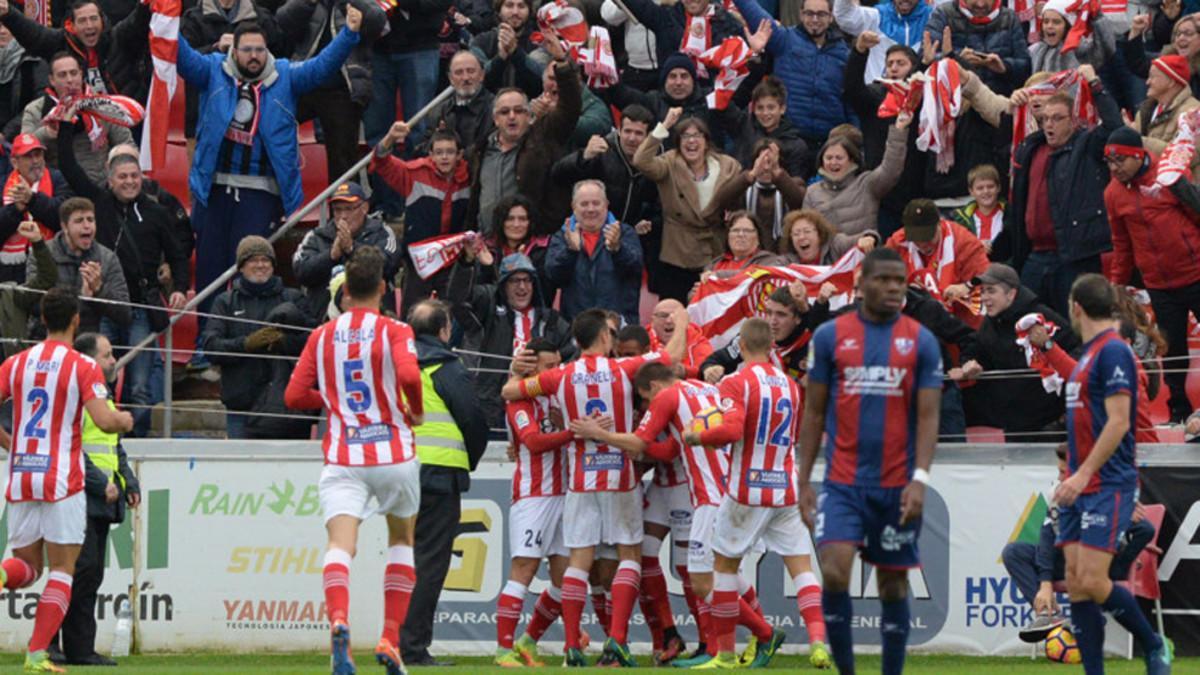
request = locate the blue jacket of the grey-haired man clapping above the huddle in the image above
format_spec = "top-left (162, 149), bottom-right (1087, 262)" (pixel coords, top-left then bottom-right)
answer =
top-left (546, 214), bottom-right (642, 324)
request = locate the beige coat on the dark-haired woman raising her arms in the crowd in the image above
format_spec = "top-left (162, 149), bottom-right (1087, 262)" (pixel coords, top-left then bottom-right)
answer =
top-left (634, 136), bottom-right (742, 271)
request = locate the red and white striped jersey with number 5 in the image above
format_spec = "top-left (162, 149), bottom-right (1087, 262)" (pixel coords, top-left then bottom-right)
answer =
top-left (286, 309), bottom-right (424, 466)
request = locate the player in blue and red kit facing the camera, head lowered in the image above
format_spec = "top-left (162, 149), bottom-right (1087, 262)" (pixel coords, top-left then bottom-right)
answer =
top-left (799, 249), bottom-right (942, 675)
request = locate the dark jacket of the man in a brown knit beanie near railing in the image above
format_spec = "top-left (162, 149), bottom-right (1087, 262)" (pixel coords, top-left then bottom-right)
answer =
top-left (198, 275), bottom-right (302, 411)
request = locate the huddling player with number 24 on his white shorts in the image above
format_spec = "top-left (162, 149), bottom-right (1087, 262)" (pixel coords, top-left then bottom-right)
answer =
top-left (496, 338), bottom-right (575, 668)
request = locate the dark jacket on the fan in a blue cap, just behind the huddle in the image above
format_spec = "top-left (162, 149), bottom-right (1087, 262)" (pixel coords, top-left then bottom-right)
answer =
top-left (446, 252), bottom-right (576, 429)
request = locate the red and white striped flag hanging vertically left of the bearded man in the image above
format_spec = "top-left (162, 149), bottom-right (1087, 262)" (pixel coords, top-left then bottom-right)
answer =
top-left (139, 0), bottom-right (184, 171)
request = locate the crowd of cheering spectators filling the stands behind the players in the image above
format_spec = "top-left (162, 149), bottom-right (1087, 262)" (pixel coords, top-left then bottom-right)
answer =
top-left (0, 0), bottom-right (1200, 440)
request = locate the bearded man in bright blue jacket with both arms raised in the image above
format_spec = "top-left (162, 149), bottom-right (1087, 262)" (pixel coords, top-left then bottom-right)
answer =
top-left (175, 8), bottom-right (362, 312)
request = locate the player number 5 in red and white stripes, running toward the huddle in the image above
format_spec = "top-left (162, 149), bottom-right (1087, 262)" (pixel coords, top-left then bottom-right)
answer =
top-left (283, 246), bottom-right (424, 675)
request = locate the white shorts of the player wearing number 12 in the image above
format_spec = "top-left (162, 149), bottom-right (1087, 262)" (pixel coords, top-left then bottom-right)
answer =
top-left (712, 495), bottom-right (812, 557)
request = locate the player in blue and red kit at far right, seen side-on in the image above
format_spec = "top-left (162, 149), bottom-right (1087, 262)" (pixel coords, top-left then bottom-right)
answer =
top-left (1054, 274), bottom-right (1171, 675)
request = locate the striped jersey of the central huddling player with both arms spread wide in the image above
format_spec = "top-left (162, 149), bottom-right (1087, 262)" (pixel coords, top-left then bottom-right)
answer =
top-left (521, 352), bottom-right (670, 492)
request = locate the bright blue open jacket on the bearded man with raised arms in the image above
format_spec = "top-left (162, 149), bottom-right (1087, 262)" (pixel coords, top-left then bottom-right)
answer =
top-left (178, 28), bottom-right (359, 213)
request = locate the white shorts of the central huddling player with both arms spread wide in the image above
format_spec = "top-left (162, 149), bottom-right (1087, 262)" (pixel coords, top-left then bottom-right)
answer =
top-left (563, 488), bottom-right (643, 549)
